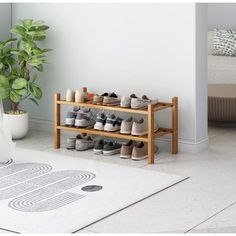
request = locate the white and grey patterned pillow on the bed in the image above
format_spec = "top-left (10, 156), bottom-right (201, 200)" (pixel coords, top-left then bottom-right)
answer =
top-left (213, 29), bottom-right (236, 57)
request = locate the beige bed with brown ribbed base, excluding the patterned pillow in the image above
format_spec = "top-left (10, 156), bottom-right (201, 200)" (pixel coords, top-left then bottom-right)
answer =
top-left (208, 31), bottom-right (236, 122)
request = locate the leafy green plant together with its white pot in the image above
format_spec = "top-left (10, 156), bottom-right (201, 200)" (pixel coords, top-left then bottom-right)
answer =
top-left (0, 19), bottom-right (51, 139)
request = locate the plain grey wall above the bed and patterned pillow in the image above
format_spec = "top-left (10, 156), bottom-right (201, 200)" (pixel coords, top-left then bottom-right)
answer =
top-left (208, 3), bottom-right (236, 30)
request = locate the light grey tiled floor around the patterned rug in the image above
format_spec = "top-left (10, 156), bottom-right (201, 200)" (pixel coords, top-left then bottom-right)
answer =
top-left (0, 127), bottom-right (236, 233)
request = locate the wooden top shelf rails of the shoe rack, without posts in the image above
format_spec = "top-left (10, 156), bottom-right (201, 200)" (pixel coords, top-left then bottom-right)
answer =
top-left (57, 100), bottom-right (173, 115)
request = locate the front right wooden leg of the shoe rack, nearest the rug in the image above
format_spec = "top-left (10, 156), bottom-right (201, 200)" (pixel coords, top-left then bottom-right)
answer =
top-left (148, 104), bottom-right (154, 164)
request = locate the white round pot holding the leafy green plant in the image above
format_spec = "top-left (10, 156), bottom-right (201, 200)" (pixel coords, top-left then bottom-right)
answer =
top-left (3, 113), bottom-right (29, 139)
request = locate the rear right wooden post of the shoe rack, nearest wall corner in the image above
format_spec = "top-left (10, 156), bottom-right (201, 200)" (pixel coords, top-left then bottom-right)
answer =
top-left (172, 97), bottom-right (178, 154)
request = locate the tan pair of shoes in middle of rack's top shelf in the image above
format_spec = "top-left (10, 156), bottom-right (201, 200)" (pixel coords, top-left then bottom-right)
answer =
top-left (93, 92), bottom-right (120, 105)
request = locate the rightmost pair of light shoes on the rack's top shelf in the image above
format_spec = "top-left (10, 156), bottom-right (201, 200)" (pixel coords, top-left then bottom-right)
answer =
top-left (120, 94), bottom-right (158, 109)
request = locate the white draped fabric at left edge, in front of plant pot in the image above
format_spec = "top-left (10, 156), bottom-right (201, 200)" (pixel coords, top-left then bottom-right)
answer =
top-left (0, 100), bottom-right (15, 163)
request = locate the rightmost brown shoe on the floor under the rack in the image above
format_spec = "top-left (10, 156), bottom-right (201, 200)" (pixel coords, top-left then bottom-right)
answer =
top-left (131, 142), bottom-right (158, 161)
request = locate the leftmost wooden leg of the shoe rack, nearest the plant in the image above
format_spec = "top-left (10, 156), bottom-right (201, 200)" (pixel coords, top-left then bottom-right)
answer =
top-left (54, 93), bottom-right (61, 149)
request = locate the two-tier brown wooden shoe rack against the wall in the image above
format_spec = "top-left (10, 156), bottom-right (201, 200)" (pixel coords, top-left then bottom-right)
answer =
top-left (54, 93), bottom-right (178, 164)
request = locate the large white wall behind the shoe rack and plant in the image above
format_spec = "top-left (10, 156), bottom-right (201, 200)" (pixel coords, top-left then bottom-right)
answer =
top-left (12, 3), bottom-right (206, 151)
